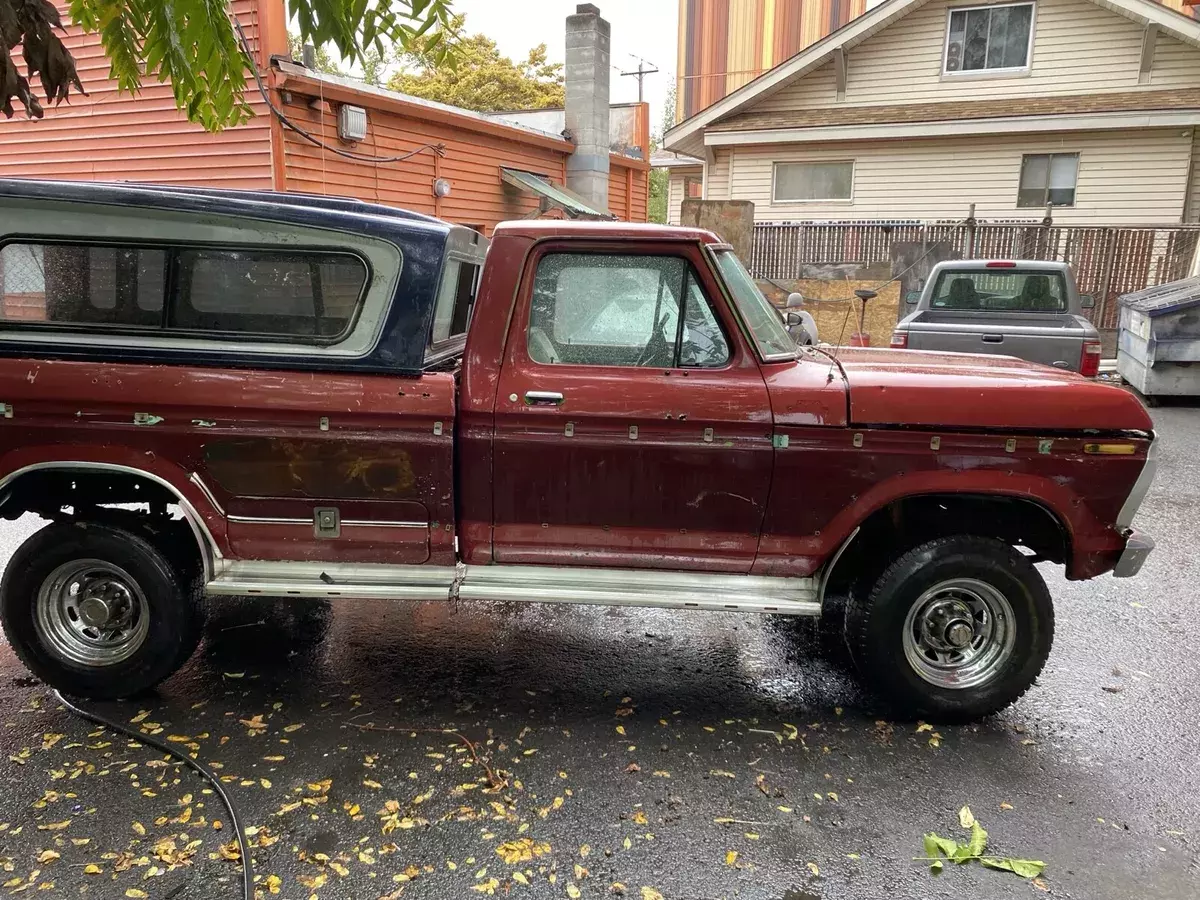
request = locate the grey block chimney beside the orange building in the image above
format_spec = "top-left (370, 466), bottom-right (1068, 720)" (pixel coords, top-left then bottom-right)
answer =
top-left (565, 4), bottom-right (611, 210)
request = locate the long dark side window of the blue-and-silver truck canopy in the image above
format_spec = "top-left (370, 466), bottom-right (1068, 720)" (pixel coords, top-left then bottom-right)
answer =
top-left (0, 241), bottom-right (368, 344)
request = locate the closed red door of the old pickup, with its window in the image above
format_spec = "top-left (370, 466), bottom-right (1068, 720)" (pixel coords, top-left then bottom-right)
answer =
top-left (492, 241), bottom-right (774, 572)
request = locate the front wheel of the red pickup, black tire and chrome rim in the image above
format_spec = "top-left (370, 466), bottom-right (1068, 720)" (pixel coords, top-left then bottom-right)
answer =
top-left (846, 536), bottom-right (1054, 722)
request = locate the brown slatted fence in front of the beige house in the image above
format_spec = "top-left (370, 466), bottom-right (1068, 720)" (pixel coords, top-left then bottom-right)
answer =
top-left (750, 222), bottom-right (1200, 328)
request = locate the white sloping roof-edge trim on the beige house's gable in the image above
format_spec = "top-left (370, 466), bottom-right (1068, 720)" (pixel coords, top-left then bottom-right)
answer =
top-left (662, 0), bottom-right (1200, 154)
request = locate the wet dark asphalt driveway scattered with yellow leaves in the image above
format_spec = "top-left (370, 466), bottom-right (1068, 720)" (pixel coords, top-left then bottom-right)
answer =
top-left (0, 408), bottom-right (1200, 900)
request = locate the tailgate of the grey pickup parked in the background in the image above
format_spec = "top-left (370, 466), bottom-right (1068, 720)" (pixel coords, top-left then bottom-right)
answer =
top-left (907, 310), bottom-right (1087, 370)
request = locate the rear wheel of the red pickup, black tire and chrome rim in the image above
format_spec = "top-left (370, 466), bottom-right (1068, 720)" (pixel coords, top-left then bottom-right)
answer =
top-left (0, 522), bottom-right (200, 700)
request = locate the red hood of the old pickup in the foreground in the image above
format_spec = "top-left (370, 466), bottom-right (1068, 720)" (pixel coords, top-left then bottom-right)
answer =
top-left (838, 348), bottom-right (1153, 431)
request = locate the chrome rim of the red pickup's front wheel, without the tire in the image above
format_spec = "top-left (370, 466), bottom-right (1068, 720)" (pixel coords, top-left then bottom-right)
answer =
top-left (904, 578), bottom-right (1016, 689)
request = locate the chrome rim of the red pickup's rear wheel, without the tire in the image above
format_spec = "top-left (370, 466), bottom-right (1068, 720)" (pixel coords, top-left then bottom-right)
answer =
top-left (34, 559), bottom-right (150, 666)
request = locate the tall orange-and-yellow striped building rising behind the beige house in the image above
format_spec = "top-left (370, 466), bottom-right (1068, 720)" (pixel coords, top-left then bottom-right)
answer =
top-left (676, 0), bottom-right (1198, 122)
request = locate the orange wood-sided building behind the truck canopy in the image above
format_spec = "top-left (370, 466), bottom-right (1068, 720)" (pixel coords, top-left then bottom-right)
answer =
top-left (0, 0), bottom-right (649, 233)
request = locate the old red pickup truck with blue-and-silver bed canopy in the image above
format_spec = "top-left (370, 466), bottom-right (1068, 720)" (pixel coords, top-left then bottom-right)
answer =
top-left (0, 180), bottom-right (1153, 720)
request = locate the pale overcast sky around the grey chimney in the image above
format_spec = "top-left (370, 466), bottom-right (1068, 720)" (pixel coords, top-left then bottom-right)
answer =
top-left (452, 0), bottom-right (679, 132)
